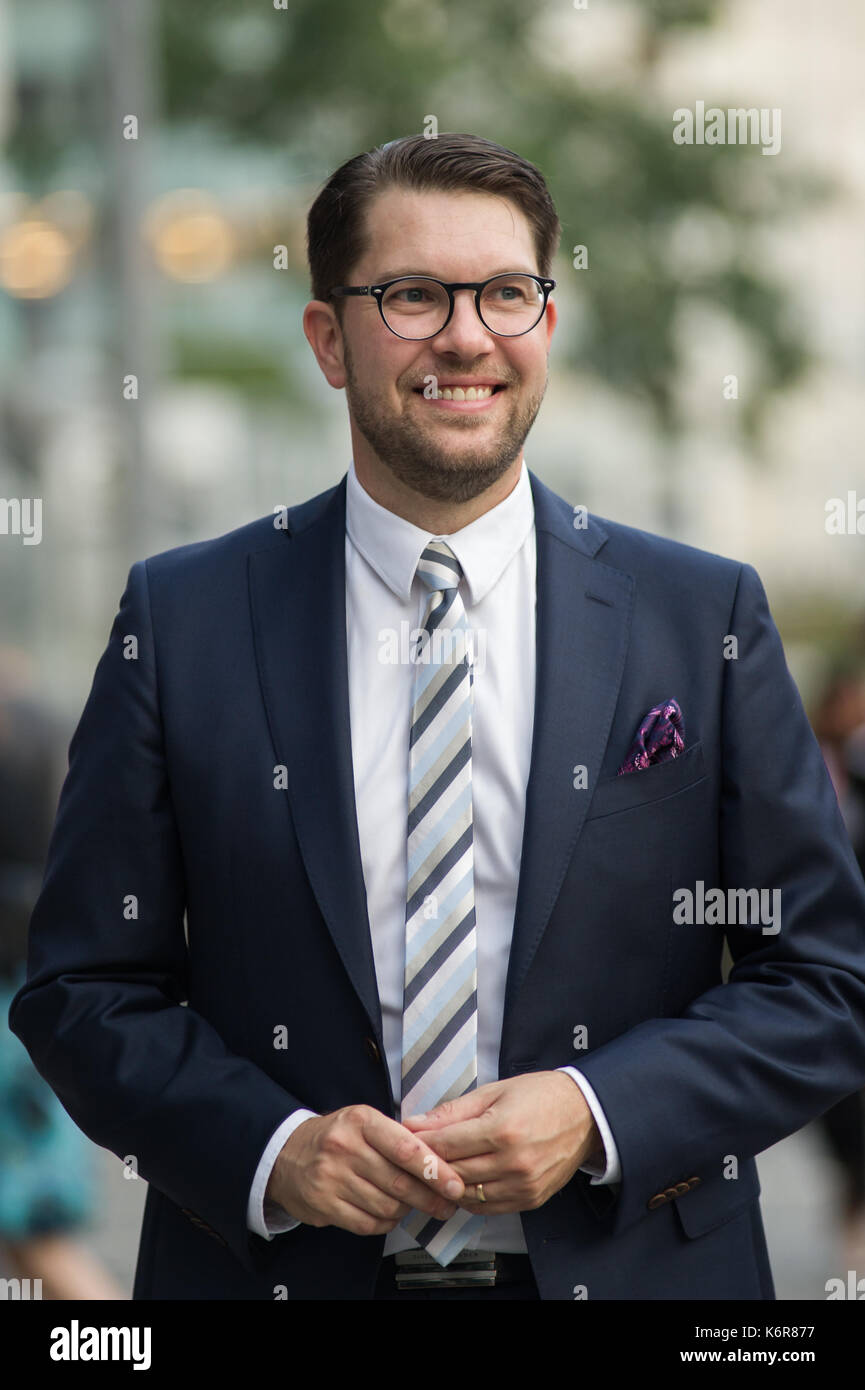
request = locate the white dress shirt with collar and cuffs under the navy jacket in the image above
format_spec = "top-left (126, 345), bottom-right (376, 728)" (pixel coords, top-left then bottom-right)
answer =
top-left (246, 460), bottom-right (620, 1255)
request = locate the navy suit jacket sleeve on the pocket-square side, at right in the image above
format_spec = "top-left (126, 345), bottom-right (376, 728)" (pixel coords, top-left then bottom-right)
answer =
top-left (580, 564), bottom-right (865, 1232)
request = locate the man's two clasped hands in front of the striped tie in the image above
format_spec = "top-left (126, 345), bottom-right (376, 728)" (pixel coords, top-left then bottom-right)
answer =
top-left (267, 1072), bottom-right (604, 1236)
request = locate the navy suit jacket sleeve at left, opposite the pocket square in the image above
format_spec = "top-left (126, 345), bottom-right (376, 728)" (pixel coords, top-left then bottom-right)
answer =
top-left (10, 562), bottom-right (311, 1272)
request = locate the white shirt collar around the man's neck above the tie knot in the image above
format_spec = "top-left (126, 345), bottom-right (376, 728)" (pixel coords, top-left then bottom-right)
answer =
top-left (345, 459), bottom-right (534, 603)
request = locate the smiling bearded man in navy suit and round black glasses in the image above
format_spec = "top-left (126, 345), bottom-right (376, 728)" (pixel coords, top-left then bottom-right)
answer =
top-left (10, 135), bottom-right (865, 1300)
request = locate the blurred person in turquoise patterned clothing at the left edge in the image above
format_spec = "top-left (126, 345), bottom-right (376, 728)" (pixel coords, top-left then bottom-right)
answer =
top-left (0, 648), bottom-right (124, 1300)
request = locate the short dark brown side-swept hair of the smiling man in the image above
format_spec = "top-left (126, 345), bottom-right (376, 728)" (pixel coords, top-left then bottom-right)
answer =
top-left (306, 133), bottom-right (562, 317)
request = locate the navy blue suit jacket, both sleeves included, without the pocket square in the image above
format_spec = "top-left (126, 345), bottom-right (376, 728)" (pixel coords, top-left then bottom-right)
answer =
top-left (10, 473), bottom-right (865, 1300)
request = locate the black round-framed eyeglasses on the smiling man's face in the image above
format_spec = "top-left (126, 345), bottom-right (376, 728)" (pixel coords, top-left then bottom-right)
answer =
top-left (330, 271), bottom-right (556, 341)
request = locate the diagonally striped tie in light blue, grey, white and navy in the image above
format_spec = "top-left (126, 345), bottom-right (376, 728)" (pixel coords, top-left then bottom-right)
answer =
top-left (401, 541), bottom-right (484, 1265)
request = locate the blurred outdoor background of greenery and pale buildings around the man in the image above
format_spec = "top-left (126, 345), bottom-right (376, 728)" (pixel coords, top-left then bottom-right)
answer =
top-left (0, 0), bottom-right (865, 1298)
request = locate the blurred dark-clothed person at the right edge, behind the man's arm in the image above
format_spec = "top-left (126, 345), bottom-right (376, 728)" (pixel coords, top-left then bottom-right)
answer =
top-left (812, 667), bottom-right (865, 1269)
